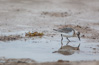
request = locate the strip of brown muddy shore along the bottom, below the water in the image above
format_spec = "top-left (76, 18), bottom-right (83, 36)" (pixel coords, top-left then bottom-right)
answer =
top-left (0, 57), bottom-right (99, 65)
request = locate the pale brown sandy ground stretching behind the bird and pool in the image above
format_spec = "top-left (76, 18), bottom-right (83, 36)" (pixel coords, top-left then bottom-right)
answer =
top-left (0, 0), bottom-right (99, 41)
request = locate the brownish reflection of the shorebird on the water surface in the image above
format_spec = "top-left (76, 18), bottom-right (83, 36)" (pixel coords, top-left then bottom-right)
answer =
top-left (53, 44), bottom-right (80, 55)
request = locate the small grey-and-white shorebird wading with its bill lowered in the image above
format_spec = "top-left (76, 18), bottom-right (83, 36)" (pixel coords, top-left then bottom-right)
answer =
top-left (53, 27), bottom-right (80, 45)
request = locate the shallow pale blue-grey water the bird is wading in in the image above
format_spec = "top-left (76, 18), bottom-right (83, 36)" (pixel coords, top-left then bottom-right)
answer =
top-left (0, 37), bottom-right (99, 62)
